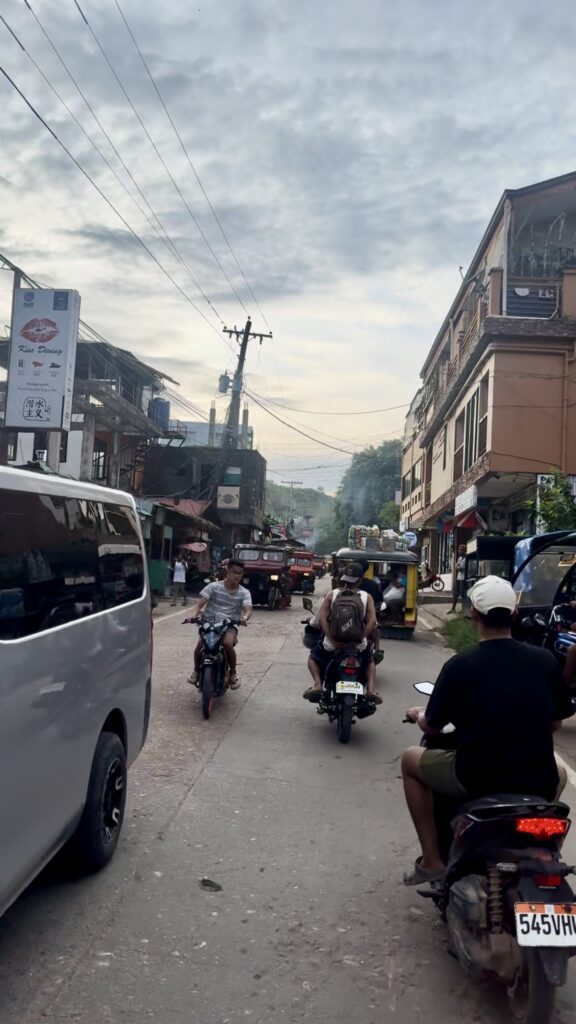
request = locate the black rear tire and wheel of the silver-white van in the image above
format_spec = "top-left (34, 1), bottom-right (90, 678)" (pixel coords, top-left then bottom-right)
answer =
top-left (65, 732), bottom-right (127, 874)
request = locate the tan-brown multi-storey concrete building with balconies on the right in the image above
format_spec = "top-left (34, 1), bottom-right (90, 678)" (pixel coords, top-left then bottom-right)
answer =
top-left (402, 173), bottom-right (576, 571)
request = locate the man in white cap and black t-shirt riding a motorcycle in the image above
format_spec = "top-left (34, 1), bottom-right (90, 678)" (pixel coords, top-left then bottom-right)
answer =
top-left (402, 575), bottom-right (574, 886)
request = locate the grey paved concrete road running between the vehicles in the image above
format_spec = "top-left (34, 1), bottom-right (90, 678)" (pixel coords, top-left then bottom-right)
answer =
top-left (0, 593), bottom-right (576, 1024)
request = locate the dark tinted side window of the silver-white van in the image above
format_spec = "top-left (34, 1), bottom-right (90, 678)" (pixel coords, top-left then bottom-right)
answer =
top-left (0, 490), bottom-right (145, 640)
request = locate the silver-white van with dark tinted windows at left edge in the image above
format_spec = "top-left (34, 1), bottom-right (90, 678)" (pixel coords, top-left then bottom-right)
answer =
top-left (0, 466), bottom-right (152, 914)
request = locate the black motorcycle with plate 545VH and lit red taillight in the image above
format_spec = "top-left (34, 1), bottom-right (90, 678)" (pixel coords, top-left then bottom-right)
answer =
top-left (405, 683), bottom-right (576, 1024)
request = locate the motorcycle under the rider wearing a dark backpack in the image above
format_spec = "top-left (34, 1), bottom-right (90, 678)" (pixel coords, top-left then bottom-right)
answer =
top-left (302, 598), bottom-right (376, 743)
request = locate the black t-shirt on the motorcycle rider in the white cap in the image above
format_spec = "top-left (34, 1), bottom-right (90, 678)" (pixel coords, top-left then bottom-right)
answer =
top-left (426, 639), bottom-right (574, 800)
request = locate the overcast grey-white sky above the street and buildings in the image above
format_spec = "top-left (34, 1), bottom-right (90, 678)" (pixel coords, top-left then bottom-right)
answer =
top-left (0, 0), bottom-right (576, 490)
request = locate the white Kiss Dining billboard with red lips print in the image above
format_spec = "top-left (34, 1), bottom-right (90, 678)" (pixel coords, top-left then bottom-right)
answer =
top-left (4, 288), bottom-right (80, 430)
